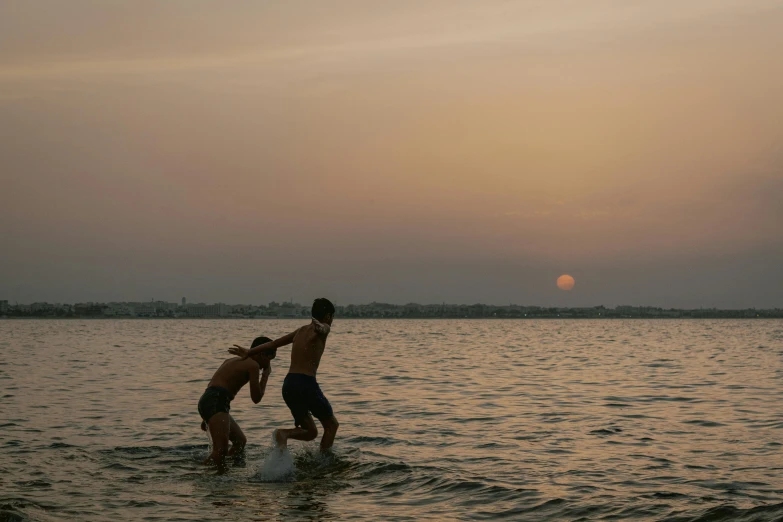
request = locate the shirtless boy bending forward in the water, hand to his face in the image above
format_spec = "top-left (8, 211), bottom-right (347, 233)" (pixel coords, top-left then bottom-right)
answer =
top-left (198, 337), bottom-right (277, 472)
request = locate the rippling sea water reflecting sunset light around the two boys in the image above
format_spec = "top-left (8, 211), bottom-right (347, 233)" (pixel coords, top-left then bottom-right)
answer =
top-left (0, 318), bottom-right (783, 522)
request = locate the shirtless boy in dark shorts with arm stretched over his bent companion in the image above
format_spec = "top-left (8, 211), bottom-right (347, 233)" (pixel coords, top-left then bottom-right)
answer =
top-left (229, 298), bottom-right (340, 451)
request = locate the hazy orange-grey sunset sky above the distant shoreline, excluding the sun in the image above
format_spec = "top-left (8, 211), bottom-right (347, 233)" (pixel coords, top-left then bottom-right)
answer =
top-left (0, 0), bottom-right (783, 308)
